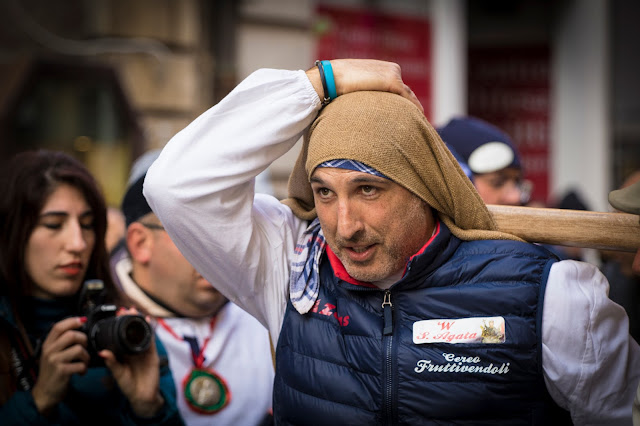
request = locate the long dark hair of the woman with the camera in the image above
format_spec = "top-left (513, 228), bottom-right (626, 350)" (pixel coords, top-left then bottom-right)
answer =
top-left (0, 149), bottom-right (116, 308)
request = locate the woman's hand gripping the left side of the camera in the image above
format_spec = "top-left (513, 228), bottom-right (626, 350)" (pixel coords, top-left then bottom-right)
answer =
top-left (31, 317), bottom-right (90, 414)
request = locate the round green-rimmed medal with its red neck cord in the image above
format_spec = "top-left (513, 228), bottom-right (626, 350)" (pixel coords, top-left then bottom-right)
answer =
top-left (157, 316), bottom-right (231, 414)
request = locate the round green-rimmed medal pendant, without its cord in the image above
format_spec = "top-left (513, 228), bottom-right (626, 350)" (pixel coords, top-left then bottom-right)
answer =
top-left (182, 367), bottom-right (231, 414)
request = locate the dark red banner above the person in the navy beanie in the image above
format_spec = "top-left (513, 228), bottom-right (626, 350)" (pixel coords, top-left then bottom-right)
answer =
top-left (468, 46), bottom-right (550, 203)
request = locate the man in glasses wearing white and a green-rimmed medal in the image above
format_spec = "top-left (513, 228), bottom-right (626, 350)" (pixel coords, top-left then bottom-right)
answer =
top-left (112, 151), bottom-right (274, 425)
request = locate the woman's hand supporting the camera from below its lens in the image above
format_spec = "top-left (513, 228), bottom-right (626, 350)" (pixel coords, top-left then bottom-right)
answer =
top-left (98, 308), bottom-right (164, 417)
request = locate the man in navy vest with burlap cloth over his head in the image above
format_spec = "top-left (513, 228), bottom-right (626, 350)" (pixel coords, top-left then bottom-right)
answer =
top-left (144, 59), bottom-right (640, 425)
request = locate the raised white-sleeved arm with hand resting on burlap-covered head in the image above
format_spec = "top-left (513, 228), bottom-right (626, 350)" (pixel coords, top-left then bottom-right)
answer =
top-left (144, 59), bottom-right (420, 331)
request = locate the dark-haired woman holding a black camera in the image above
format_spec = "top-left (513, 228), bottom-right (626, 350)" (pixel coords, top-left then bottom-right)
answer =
top-left (0, 150), bottom-right (182, 425)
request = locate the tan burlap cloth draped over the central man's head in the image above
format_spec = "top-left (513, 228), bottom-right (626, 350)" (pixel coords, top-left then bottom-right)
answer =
top-left (282, 92), bottom-right (522, 241)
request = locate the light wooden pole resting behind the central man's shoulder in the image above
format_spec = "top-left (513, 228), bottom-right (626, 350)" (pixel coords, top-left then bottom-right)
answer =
top-left (487, 204), bottom-right (640, 252)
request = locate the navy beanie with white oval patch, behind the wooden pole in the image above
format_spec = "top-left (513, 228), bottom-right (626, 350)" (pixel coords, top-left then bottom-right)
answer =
top-left (436, 117), bottom-right (522, 173)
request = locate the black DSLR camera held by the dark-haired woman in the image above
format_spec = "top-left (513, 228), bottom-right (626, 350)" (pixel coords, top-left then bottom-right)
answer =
top-left (79, 280), bottom-right (152, 365)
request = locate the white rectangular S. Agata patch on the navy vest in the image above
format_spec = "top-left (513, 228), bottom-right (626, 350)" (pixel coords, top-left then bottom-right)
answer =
top-left (413, 317), bottom-right (505, 344)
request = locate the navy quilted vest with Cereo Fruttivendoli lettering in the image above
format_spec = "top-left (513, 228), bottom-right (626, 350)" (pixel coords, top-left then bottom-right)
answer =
top-left (274, 223), bottom-right (570, 425)
